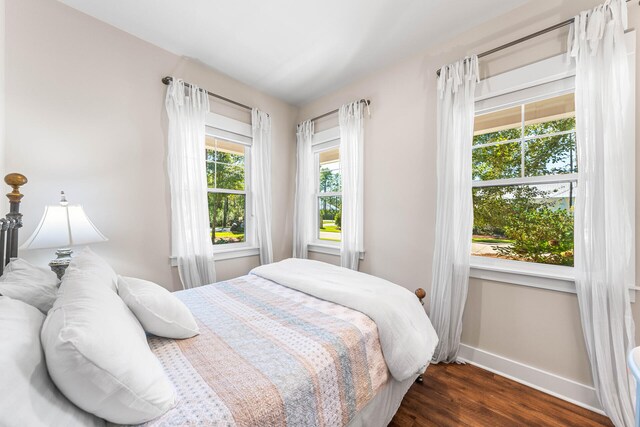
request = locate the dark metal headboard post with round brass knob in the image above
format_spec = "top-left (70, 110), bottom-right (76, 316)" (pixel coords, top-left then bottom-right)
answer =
top-left (0, 173), bottom-right (27, 274)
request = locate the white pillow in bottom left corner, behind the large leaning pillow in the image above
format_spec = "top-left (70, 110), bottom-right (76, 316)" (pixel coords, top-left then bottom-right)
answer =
top-left (0, 297), bottom-right (105, 427)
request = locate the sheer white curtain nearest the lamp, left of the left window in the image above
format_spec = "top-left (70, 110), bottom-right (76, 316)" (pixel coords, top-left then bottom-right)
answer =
top-left (165, 79), bottom-right (216, 289)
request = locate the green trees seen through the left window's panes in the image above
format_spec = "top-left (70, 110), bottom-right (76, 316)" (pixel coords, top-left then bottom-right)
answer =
top-left (206, 135), bottom-right (247, 245)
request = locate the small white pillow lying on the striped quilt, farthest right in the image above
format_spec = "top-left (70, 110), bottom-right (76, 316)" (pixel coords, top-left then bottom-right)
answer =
top-left (118, 276), bottom-right (200, 339)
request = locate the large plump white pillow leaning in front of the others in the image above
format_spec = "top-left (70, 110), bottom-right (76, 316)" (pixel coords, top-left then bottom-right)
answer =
top-left (41, 270), bottom-right (176, 424)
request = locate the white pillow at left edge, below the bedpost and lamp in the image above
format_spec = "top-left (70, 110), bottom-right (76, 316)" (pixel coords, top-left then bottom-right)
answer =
top-left (0, 259), bottom-right (60, 314)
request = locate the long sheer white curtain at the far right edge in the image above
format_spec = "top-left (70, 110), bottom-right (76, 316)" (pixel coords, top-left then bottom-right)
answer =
top-left (569, 0), bottom-right (634, 427)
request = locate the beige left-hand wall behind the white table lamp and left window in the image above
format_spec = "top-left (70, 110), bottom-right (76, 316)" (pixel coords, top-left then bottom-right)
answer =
top-left (5, 0), bottom-right (296, 289)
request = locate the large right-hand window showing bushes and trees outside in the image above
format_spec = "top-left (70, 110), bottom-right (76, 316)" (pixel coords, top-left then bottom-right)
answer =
top-left (472, 93), bottom-right (578, 266)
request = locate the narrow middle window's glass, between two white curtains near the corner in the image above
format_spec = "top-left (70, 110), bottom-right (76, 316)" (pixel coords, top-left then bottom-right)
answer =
top-left (315, 144), bottom-right (342, 243)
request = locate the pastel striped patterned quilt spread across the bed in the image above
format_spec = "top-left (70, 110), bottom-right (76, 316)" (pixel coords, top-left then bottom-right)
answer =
top-left (142, 275), bottom-right (388, 427)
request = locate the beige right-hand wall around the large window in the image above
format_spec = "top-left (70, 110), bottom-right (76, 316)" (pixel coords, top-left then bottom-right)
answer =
top-left (298, 0), bottom-right (640, 392)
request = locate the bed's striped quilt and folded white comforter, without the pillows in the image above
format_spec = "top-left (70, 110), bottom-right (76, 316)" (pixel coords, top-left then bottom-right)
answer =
top-left (0, 176), bottom-right (437, 426)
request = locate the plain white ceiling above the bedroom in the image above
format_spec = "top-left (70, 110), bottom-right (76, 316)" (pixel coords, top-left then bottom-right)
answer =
top-left (60, 0), bottom-right (526, 105)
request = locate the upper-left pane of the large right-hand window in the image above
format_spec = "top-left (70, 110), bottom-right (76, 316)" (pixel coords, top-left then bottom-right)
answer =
top-left (473, 106), bottom-right (522, 145)
